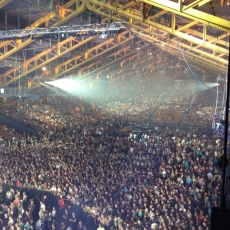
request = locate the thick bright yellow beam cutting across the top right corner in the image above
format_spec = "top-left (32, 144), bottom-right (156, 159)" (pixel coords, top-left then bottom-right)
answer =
top-left (143, 0), bottom-right (230, 32)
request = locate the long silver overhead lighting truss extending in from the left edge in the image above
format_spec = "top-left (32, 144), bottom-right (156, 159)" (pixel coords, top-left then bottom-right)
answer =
top-left (0, 22), bottom-right (126, 40)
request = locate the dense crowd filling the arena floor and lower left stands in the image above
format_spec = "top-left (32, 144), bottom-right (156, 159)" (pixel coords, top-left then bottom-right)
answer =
top-left (0, 96), bottom-right (223, 230)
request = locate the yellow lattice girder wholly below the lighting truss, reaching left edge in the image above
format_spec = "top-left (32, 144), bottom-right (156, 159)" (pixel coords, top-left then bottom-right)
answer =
top-left (0, 36), bottom-right (95, 86)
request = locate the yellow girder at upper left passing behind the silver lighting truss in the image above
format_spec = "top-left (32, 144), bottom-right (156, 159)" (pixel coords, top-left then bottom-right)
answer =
top-left (0, 0), bottom-right (86, 61)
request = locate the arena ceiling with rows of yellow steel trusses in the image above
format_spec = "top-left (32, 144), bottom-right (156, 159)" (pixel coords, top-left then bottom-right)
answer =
top-left (0, 0), bottom-right (230, 88)
